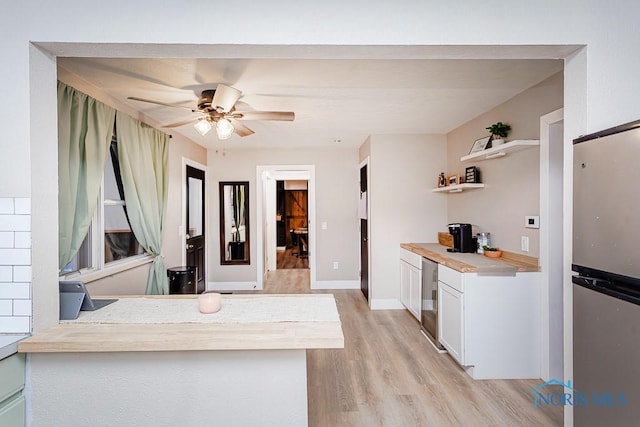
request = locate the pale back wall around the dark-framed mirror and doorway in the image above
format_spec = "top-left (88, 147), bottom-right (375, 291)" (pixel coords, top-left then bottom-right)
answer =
top-left (207, 146), bottom-right (359, 283)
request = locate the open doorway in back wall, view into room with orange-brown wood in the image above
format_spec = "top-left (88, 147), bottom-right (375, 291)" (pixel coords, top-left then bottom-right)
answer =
top-left (276, 180), bottom-right (309, 270)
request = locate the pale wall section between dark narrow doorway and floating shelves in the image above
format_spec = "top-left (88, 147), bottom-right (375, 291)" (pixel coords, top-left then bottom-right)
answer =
top-left (368, 135), bottom-right (447, 308)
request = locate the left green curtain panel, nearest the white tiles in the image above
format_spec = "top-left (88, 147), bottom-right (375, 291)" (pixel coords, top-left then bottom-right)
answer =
top-left (58, 82), bottom-right (115, 271)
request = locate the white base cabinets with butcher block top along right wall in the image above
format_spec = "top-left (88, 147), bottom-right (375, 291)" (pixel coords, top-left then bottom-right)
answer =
top-left (400, 243), bottom-right (542, 379)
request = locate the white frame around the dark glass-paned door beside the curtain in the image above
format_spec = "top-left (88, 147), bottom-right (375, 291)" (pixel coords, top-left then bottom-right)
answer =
top-left (178, 157), bottom-right (212, 291)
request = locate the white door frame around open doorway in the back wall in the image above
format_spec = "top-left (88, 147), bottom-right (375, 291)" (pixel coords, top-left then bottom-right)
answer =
top-left (255, 165), bottom-right (316, 290)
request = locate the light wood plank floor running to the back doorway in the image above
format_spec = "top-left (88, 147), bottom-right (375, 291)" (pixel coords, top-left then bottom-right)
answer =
top-left (263, 269), bottom-right (562, 427)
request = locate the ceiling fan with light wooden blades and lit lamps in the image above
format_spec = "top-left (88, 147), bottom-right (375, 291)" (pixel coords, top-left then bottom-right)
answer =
top-left (127, 84), bottom-right (295, 139)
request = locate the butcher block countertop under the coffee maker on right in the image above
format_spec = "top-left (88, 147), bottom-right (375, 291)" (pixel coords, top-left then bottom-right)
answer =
top-left (400, 243), bottom-right (540, 276)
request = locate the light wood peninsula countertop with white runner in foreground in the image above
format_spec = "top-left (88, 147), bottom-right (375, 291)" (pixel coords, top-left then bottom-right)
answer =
top-left (18, 294), bottom-right (344, 353)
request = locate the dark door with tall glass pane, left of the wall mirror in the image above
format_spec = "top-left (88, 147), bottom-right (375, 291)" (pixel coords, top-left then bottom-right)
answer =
top-left (186, 165), bottom-right (206, 293)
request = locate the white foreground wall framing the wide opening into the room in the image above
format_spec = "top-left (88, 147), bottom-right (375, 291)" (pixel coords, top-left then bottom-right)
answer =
top-left (5, 8), bottom-right (640, 426)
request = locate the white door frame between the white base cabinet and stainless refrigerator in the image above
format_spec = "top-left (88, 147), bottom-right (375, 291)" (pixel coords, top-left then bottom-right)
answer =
top-left (540, 108), bottom-right (565, 381)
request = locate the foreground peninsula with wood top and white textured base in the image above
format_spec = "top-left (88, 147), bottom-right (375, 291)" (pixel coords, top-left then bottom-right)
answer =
top-left (18, 294), bottom-right (344, 426)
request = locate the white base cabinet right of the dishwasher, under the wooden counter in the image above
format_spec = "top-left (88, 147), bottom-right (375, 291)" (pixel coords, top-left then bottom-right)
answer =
top-left (438, 264), bottom-right (541, 379)
